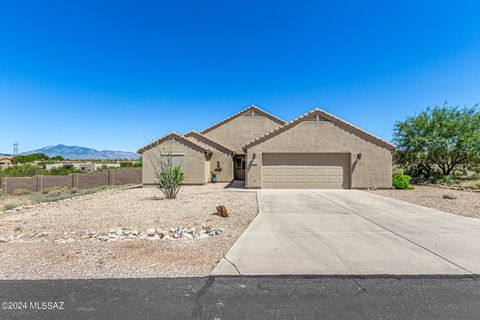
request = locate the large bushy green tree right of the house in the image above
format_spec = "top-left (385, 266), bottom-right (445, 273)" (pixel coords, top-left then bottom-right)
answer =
top-left (394, 103), bottom-right (480, 175)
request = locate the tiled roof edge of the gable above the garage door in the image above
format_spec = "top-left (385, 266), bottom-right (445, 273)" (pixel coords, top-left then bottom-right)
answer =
top-left (243, 108), bottom-right (396, 151)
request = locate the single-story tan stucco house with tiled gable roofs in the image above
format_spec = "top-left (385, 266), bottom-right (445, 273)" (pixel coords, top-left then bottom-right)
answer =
top-left (138, 106), bottom-right (395, 189)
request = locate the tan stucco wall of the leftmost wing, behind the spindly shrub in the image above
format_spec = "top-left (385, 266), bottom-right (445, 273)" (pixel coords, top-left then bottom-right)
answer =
top-left (142, 140), bottom-right (210, 184)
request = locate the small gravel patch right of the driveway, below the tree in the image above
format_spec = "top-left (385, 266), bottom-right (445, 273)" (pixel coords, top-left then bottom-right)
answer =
top-left (369, 186), bottom-right (480, 218)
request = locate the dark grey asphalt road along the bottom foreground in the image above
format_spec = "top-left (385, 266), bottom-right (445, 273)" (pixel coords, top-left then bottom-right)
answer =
top-left (0, 276), bottom-right (480, 320)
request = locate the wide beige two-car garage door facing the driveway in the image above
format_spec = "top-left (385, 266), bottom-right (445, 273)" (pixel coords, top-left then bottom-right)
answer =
top-left (262, 153), bottom-right (350, 189)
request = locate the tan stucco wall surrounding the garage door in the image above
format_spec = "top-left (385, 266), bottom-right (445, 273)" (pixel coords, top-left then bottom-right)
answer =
top-left (246, 121), bottom-right (392, 188)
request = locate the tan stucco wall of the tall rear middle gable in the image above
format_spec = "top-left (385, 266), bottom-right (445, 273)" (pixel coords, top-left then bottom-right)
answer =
top-left (204, 111), bottom-right (280, 154)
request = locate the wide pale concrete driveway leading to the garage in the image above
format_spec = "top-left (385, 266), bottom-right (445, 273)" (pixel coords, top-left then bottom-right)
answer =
top-left (213, 190), bottom-right (480, 275)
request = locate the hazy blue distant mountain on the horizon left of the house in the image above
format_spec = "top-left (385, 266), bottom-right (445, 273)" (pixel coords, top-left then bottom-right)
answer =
top-left (22, 144), bottom-right (139, 160)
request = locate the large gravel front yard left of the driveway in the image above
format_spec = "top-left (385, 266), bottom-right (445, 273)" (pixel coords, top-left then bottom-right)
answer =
top-left (0, 183), bottom-right (257, 279)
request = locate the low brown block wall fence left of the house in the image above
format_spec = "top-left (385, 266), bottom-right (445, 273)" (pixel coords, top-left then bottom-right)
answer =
top-left (2, 168), bottom-right (142, 195)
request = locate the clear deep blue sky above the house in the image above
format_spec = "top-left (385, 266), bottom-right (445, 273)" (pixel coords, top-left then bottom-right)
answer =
top-left (0, 0), bottom-right (480, 153)
